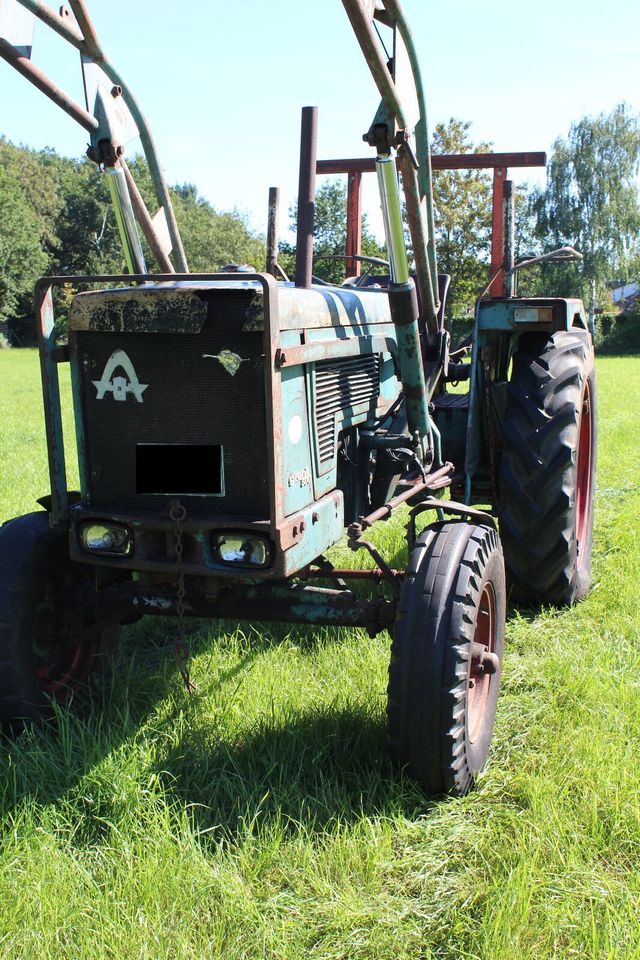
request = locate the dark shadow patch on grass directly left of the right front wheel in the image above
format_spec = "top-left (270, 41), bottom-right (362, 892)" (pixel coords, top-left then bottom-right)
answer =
top-left (152, 705), bottom-right (433, 846)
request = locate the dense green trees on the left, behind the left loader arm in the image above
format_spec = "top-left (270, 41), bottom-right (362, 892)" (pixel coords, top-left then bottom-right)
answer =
top-left (0, 138), bottom-right (265, 343)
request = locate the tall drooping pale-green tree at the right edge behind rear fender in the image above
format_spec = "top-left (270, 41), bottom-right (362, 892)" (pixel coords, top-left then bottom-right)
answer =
top-left (531, 103), bottom-right (640, 299)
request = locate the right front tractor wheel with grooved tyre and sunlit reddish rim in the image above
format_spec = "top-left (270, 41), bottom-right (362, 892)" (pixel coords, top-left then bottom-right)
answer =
top-left (388, 521), bottom-right (506, 796)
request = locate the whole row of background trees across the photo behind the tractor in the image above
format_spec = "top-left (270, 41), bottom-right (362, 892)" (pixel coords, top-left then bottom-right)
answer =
top-left (0, 104), bottom-right (640, 343)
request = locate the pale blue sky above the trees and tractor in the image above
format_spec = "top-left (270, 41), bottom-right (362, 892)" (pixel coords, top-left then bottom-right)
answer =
top-left (0, 0), bottom-right (640, 240)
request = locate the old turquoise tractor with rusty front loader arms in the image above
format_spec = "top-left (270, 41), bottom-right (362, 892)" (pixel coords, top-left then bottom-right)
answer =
top-left (0, 0), bottom-right (596, 795)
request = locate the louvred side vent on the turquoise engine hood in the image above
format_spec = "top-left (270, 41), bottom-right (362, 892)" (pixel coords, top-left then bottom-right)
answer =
top-left (314, 354), bottom-right (380, 465)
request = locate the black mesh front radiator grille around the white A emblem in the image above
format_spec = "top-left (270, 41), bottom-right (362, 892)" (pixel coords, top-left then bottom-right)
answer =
top-left (76, 293), bottom-right (269, 517)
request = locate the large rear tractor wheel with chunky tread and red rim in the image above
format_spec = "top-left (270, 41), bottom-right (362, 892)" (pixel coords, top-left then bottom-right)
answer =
top-left (499, 329), bottom-right (597, 606)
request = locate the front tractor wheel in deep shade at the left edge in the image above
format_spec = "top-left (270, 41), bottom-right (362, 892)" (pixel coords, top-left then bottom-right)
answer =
top-left (0, 513), bottom-right (120, 731)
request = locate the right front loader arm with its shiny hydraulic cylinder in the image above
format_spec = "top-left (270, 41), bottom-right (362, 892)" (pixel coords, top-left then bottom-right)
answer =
top-left (342, 0), bottom-right (439, 464)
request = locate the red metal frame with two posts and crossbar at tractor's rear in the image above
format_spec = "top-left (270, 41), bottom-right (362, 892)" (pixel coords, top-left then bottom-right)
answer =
top-left (316, 151), bottom-right (547, 297)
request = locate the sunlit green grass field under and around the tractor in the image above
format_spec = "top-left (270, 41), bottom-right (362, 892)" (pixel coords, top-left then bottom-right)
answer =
top-left (0, 351), bottom-right (640, 960)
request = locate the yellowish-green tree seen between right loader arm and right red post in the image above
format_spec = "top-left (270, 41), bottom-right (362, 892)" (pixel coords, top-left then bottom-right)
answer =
top-left (431, 117), bottom-right (491, 317)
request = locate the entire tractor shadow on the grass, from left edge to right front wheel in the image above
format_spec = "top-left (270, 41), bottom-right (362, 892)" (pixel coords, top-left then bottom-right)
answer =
top-left (0, 621), bottom-right (432, 846)
